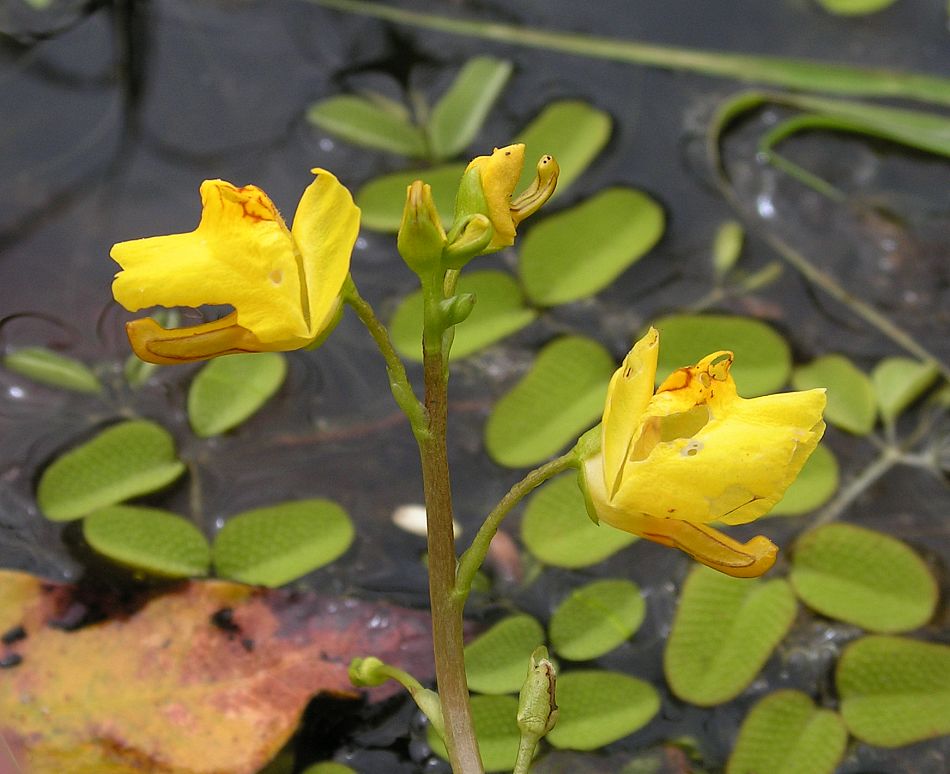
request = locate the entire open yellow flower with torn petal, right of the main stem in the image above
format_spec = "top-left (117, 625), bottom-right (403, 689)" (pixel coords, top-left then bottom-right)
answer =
top-left (581, 328), bottom-right (825, 578)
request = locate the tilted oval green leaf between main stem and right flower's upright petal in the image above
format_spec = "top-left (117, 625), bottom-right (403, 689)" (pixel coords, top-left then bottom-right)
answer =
top-left (488, 334), bottom-right (616, 468)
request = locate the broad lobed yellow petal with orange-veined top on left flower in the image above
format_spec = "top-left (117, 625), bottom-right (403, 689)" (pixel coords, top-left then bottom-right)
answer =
top-left (111, 180), bottom-right (310, 342)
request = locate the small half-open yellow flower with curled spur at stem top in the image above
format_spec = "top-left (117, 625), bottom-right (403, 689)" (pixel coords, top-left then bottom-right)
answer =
top-left (449, 143), bottom-right (559, 253)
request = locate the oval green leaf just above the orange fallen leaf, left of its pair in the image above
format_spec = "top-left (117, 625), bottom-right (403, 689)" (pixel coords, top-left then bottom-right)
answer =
top-left (82, 505), bottom-right (211, 578)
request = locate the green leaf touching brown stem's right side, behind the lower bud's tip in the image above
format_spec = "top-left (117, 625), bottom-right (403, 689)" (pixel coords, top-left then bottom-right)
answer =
top-left (465, 615), bottom-right (544, 694)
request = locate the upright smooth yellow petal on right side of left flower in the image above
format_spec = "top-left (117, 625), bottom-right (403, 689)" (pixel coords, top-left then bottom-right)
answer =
top-left (291, 168), bottom-right (360, 339)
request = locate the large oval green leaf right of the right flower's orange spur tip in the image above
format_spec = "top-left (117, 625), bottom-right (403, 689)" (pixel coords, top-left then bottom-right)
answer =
top-left (789, 524), bottom-right (938, 632)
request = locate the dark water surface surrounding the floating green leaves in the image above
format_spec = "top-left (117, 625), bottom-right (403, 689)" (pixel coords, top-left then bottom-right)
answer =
top-left (0, 0), bottom-right (950, 772)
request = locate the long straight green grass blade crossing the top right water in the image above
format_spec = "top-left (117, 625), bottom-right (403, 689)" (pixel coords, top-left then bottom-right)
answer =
top-left (311, 0), bottom-right (950, 105)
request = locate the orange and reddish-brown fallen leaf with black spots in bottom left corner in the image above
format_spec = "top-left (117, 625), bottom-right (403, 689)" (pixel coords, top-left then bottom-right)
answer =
top-left (0, 571), bottom-right (432, 774)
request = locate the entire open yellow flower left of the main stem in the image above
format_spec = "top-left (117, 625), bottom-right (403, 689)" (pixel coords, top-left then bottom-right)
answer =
top-left (111, 169), bottom-right (360, 364)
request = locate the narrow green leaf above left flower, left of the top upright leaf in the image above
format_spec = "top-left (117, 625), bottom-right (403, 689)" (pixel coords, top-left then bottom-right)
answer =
top-left (307, 94), bottom-right (428, 158)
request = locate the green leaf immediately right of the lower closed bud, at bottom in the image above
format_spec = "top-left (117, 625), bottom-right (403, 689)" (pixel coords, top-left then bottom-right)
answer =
top-left (545, 670), bottom-right (660, 750)
